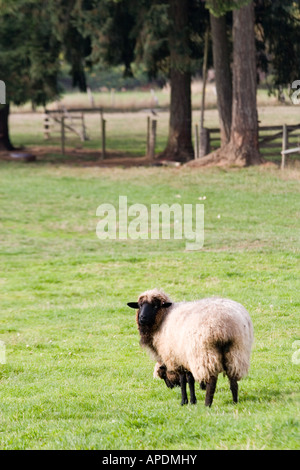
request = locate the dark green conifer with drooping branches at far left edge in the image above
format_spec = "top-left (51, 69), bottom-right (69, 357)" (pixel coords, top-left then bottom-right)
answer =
top-left (0, 0), bottom-right (90, 150)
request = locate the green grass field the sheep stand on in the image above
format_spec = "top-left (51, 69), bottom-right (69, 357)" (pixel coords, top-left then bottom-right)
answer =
top-left (0, 162), bottom-right (300, 450)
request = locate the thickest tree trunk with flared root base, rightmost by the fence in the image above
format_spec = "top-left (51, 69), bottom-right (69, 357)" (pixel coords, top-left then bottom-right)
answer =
top-left (190, 3), bottom-right (263, 166)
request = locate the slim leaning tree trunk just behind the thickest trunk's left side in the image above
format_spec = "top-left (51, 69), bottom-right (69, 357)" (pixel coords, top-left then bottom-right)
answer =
top-left (210, 14), bottom-right (232, 147)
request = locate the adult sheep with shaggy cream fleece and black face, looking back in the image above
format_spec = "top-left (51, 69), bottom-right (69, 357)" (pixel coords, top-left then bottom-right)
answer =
top-left (127, 289), bottom-right (253, 406)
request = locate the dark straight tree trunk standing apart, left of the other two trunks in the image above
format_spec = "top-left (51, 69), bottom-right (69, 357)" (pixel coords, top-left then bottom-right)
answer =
top-left (160, 0), bottom-right (194, 162)
